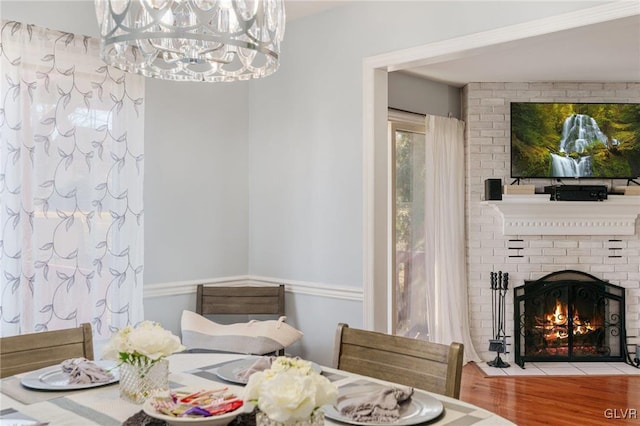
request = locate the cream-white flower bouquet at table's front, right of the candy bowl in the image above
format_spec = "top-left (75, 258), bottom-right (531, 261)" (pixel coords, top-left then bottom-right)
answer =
top-left (244, 356), bottom-right (338, 423)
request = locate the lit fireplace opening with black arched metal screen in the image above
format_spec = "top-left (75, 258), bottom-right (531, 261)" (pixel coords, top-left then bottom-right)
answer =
top-left (513, 271), bottom-right (626, 367)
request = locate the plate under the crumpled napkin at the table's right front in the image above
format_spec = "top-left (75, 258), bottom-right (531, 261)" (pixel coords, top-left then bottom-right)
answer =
top-left (322, 385), bottom-right (444, 426)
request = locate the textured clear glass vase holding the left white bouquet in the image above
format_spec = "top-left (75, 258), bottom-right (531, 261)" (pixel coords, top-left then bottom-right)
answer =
top-left (120, 359), bottom-right (169, 404)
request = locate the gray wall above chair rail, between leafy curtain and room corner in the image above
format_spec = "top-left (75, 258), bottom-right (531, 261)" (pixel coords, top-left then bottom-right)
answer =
top-left (144, 79), bottom-right (249, 284)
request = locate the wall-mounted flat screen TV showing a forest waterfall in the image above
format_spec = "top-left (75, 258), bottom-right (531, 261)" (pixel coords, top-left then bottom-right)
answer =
top-left (511, 102), bottom-right (640, 179)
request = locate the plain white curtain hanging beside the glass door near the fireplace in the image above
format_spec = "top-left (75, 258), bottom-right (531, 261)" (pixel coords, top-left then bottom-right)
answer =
top-left (425, 115), bottom-right (480, 361)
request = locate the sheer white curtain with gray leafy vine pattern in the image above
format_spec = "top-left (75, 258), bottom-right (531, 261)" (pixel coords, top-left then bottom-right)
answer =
top-left (0, 21), bottom-right (144, 350)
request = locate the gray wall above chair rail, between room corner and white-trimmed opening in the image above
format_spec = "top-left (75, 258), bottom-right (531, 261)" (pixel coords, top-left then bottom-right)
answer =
top-left (249, 1), bottom-right (600, 287)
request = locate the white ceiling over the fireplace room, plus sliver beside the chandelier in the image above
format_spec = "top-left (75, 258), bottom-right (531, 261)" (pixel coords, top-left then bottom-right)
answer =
top-left (286, 0), bottom-right (640, 86)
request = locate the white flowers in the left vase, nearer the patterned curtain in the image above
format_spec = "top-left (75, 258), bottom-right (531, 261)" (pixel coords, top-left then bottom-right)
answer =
top-left (103, 321), bottom-right (185, 365)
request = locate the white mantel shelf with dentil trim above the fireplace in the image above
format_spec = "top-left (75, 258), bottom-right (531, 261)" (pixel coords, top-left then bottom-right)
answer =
top-left (482, 194), bottom-right (640, 236)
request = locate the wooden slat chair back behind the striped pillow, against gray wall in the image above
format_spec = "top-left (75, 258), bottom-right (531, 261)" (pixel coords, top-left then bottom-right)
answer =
top-left (196, 284), bottom-right (285, 355)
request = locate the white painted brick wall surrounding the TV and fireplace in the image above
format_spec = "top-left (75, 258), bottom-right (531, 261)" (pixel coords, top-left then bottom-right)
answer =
top-left (462, 82), bottom-right (640, 362)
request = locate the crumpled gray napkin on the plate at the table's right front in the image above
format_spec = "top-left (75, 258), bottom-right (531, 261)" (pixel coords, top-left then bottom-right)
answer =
top-left (340, 387), bottom-right (413, 423)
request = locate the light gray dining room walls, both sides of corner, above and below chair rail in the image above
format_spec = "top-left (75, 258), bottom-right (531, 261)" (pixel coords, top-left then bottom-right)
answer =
top-left (0, 0), bottom-right (608, 363)
